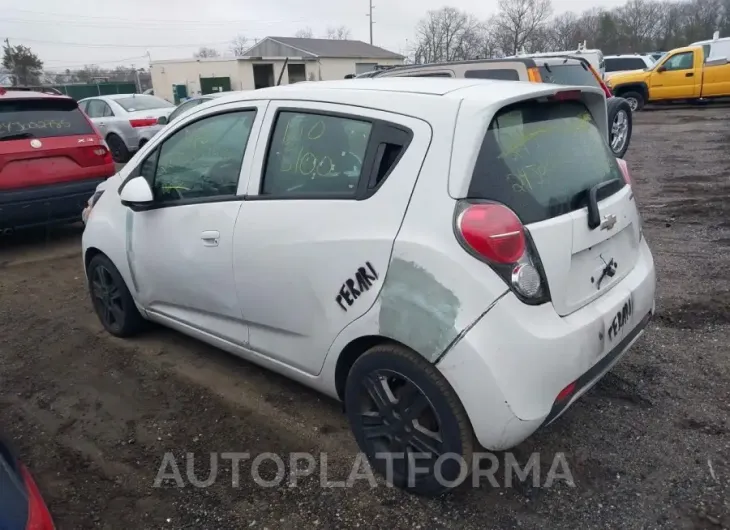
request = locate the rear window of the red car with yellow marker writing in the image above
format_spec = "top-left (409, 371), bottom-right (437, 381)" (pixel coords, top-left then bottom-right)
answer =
top-left (0, 98), bottom-right (94, 141)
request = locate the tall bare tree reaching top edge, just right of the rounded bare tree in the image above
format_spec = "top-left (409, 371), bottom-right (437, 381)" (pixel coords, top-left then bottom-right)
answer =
top-left (494, 0), bottom-right (552, 55)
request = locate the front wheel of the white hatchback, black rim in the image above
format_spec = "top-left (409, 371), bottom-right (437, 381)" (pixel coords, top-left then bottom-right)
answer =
top-left (87, 254), bottom-right (146, 337)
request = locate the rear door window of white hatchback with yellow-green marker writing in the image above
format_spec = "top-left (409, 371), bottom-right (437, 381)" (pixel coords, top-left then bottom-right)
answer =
top-left (260, 111), bottom-right (373, 197)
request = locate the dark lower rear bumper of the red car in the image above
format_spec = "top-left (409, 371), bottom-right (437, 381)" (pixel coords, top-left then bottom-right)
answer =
top-left (0, 177), bottom-right (107, 230)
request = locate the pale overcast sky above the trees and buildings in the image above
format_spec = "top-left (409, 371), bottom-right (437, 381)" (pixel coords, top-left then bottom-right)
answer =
top-left (0, 0), bottom-right (625, 71)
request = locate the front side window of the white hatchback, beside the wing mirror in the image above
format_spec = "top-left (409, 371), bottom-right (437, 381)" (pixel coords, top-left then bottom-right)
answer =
top-left (140, 110), bottom-right (256, 203)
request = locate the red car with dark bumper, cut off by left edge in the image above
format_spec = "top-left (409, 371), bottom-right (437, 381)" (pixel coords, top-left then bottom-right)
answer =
top-left (0, 87), bottom-right (116, 233)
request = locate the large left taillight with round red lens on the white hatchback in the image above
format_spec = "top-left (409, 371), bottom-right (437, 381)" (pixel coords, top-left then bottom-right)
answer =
top-left (455, 201), bottom-right (548, 304)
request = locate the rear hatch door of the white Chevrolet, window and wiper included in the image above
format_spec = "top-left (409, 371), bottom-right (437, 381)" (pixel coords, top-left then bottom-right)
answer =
top-left (469, 92), bottom-right (640, 316)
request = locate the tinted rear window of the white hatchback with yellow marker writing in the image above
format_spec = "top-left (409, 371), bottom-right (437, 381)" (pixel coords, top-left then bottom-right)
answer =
top-left (469, 101), bottom-right (624, 224)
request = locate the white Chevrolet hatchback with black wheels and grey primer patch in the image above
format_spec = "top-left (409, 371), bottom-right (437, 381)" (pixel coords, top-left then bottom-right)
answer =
top-left (83, 78), bottom-right (655, 494)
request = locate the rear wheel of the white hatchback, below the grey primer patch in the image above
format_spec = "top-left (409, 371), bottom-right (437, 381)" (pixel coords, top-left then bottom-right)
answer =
top-left (344, 343), bottom-right (475, 496)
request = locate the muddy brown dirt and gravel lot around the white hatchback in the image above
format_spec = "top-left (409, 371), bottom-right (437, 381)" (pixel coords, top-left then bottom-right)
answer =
top-left (0, 107), bottom-right (730, 529)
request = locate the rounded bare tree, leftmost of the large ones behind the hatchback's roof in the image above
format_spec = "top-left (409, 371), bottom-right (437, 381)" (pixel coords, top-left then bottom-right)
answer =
top-left (413, 7), bottom-right (484, 63)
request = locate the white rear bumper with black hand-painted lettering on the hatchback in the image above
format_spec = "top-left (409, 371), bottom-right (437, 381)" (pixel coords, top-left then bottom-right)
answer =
top-left (437, 237), bottom-right (656, 450)
